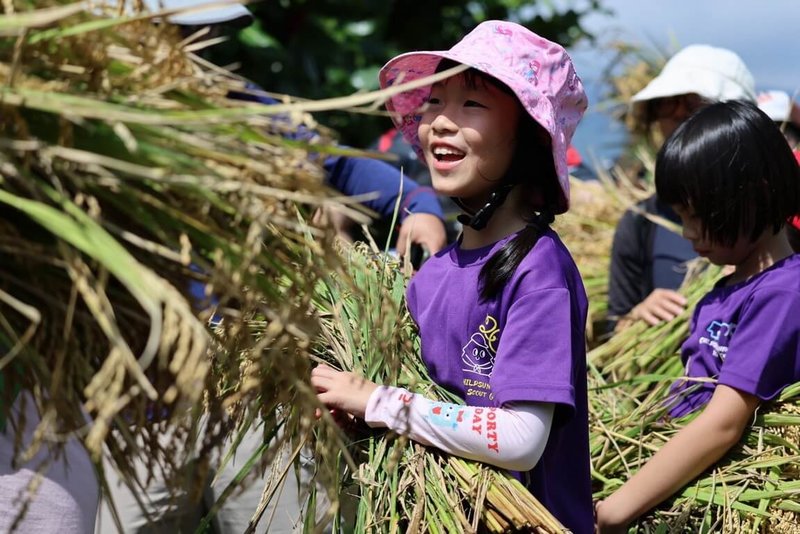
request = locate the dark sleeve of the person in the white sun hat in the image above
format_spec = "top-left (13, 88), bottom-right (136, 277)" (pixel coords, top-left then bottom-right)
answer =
top-left (608, 210), bottom-right (646, 320)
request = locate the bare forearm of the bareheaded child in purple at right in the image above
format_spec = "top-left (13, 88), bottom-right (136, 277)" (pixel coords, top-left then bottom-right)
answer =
top-left (597, 384), bottom-right (760, 534)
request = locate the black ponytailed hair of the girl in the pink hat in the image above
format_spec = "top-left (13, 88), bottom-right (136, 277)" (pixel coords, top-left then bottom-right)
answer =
top-left (436, 59), bottom-right (566, 301)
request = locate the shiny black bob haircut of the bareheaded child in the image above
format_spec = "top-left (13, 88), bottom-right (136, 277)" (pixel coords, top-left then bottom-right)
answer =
top-left (655, 100), bottom-right (800, 246)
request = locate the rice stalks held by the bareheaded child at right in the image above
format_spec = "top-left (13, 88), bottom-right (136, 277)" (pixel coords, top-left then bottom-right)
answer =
top-left (589, 260), bottom-right (800, 533)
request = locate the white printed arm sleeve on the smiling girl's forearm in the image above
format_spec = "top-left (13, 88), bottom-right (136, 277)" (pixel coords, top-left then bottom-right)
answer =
top-left (364, 386), bottom-right (554, 471)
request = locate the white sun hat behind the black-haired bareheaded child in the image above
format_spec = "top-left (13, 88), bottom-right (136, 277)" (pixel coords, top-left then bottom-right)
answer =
top-left (631, 45), bottom-right (756, 115)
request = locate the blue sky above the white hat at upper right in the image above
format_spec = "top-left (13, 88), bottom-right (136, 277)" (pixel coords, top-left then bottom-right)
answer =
top-left (557, 0), bottom-right (800, 164)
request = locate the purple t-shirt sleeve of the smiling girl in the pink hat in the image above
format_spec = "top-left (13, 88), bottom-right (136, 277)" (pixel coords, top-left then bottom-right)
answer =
top-left (491, 287), bottom-right (586, 413)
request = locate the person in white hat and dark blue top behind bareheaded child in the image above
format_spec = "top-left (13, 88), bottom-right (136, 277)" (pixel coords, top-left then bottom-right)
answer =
top-left (608, 45), bottom-right (756, 330)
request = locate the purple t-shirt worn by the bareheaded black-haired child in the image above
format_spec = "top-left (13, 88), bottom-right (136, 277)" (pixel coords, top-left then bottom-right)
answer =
top-left (667, 254), bottom-right (800, 417)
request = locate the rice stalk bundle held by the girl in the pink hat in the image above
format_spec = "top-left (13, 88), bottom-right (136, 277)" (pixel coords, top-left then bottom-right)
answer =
top-left (315, 245), bottom-right (564, 533)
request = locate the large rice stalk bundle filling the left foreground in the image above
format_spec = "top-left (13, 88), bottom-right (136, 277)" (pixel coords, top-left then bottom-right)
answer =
top-left (0, 0), bottom-right (354, 510)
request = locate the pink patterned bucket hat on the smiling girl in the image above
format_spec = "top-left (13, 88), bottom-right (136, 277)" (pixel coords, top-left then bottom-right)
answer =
top-left (380, 20), bottom-right (588, 213)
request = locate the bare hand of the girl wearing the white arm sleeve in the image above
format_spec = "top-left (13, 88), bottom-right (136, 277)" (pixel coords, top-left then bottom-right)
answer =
top-left (311, 364), bottom-right (378, 419)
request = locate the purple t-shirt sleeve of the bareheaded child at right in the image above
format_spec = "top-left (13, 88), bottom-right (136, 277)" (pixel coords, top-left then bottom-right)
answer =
top-left (719, 288), bottom-right (800, 401)
